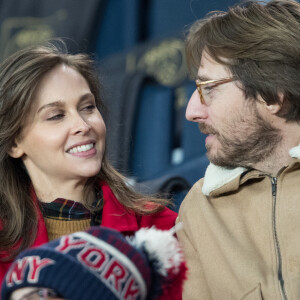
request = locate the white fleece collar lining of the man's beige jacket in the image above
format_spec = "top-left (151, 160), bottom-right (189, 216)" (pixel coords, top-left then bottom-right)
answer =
top-left (202, 144), bottom-right (300, 196)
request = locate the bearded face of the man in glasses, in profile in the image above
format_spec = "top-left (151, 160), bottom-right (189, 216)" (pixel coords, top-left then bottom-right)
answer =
top-left (186, 51), bottom-right (281, 167)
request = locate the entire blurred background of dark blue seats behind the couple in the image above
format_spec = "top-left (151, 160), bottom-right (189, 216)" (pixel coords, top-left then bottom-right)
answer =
top-left (0, 0), bottom-right (244, 209)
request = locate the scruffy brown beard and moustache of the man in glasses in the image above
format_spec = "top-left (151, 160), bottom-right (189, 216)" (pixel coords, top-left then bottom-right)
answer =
top-left (199, 105), bottom-right (282, 168)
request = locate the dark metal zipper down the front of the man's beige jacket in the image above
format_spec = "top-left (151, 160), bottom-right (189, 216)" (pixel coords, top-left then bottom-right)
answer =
top-left (271, 177), bottom-right (288, 300)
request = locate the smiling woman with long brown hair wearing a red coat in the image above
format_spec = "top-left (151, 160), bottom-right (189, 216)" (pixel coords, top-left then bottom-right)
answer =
top-left (0, 44), bottom-right (176, 282)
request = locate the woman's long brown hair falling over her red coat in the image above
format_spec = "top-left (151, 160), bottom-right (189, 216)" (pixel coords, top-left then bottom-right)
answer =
top-left (0, 43), bottom-right (167, 261)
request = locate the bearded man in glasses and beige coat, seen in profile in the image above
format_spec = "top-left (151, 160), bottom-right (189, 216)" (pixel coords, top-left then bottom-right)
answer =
top-left (178, 0), bottom-right (300, 300)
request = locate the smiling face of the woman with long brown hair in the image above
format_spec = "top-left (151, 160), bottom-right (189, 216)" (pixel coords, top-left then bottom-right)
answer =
top-left (10, 64), bottom-right (106, 188)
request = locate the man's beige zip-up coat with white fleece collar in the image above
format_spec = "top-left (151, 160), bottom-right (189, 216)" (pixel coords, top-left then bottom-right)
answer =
top-left (177, 147), bottom-right (300, 300)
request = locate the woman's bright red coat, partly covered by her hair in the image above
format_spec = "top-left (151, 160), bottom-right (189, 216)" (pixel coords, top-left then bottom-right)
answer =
top-left (0, 182), bottom-right (177, 284)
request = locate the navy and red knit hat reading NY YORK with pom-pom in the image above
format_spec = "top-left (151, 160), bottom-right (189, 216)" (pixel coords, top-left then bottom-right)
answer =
top-left (1, 227), bottom-right (186, 300)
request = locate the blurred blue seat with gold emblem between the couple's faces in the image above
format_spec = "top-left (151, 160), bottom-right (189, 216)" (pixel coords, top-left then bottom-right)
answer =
top-left (100, 37), bottom-right (208, 211)
